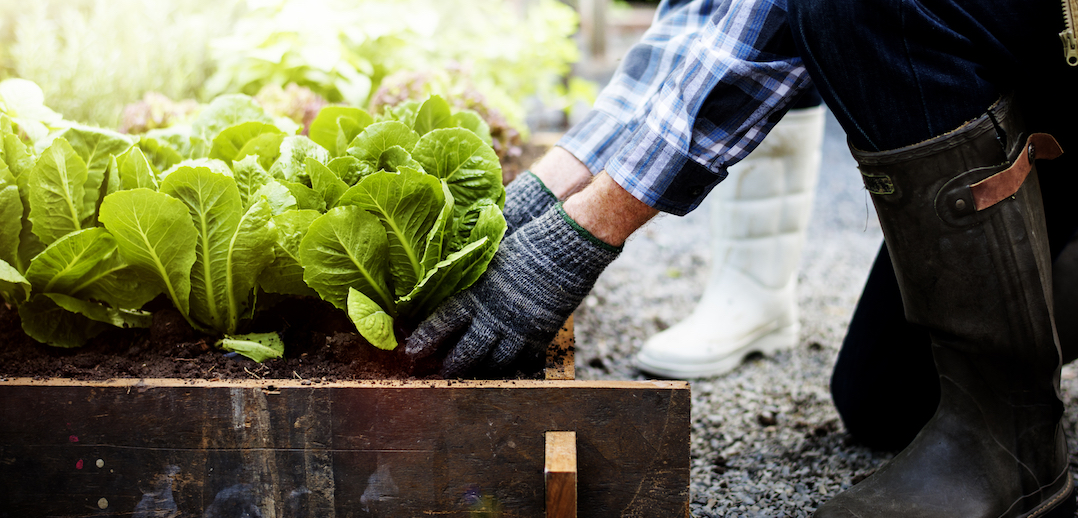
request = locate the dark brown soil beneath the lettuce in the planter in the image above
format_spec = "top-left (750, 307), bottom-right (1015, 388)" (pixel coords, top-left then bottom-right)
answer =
top-left (0, 292), bottom-right (542, 382)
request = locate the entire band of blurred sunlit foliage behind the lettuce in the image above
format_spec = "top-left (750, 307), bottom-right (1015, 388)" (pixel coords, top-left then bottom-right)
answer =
top-left (0, 0), bottom-right (591, 132)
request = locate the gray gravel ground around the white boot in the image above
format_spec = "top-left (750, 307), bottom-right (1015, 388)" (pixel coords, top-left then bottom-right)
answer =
top-left (576, 108), bottom-right (1078, 517)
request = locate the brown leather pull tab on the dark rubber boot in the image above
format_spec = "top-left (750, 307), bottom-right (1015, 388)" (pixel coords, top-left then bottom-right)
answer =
top-left (936, 134), bottom-right (1063, 225)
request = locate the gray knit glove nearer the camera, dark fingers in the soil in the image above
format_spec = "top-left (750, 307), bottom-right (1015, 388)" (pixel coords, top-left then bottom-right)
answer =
top-left (404, 204), bottom-right (621, 378)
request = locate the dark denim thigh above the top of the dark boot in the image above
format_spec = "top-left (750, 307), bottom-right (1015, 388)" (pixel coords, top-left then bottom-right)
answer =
top-left (788, 0), bottom-right (1074, 151)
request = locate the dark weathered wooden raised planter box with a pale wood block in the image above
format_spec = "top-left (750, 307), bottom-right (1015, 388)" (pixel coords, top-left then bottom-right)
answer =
top-left (0, 320), bottom-right (690, 518)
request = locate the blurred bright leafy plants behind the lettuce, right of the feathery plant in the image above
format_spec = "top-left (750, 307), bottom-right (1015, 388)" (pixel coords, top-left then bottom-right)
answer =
top-left (205, 0), bottom-right (594, 137)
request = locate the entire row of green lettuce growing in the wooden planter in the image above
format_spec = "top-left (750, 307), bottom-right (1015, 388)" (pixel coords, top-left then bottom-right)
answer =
top-left (0, 87), bottom-right (506, 359)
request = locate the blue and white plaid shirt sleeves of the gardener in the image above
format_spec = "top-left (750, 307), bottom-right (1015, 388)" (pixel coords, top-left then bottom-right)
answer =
top-left (558, 0), bottom-right (810, 215)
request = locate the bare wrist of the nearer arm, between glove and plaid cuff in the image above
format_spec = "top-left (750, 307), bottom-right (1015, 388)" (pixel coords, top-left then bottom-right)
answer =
top-left (565, 171), bottom-right (659, 247)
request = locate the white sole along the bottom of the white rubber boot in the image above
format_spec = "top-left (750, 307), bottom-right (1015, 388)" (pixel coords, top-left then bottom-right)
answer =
top-left (633, 324), bottom-right (801, 379)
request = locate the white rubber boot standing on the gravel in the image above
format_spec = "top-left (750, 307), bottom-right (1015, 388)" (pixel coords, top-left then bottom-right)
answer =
top-left (636, 107), bottom-right (824, 378)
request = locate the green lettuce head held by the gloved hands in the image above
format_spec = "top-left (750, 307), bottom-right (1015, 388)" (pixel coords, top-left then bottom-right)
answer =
top-left (299, 97), bottom-right (506, 349)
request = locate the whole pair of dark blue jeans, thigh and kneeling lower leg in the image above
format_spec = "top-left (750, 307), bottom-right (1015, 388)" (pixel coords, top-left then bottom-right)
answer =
top-left (788, 0), bottom-right (1078, 449)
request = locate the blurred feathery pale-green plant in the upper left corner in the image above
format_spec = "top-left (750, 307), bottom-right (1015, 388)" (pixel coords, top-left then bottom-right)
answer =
top-left (0, 0), bottom-right (244, 127)
